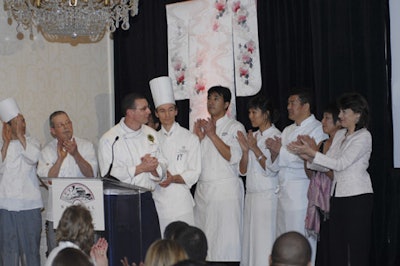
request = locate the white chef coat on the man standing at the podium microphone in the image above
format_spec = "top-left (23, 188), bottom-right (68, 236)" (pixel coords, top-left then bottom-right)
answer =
top-left (99, 118), bottom-right (166, 191)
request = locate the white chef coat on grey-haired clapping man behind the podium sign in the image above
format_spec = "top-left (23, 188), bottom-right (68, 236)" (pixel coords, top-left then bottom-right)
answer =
top-left (37, 137), bottom-right (98, 222)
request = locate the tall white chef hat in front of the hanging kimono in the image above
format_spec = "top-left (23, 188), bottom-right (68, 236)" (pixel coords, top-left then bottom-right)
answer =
top-left (149, 77), bottom-right (175, 108)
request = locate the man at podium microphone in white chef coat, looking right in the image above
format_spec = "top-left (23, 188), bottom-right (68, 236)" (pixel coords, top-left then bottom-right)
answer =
top-left (99, 93), bottom-right (166, 262)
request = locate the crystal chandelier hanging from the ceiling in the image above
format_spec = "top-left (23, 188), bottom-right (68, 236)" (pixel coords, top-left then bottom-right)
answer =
top-left (4, 0), bottom-right (139, 42)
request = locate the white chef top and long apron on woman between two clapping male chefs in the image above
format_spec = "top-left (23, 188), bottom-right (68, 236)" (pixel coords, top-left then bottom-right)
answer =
top-left (240, 125), bottom-right (281, 266)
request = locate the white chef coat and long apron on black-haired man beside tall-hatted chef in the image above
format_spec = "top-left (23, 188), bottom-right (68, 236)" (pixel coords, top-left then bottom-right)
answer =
top-left (194, 116), bottom-right (245, 261)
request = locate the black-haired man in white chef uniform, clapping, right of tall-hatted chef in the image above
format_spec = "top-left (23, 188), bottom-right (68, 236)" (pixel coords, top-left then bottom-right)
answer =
top-left (194, 86), bottom-right (245, 262)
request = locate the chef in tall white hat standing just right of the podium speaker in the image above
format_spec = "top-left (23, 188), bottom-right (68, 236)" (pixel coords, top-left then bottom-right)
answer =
top-left (150, 77), bottom-right (201, 235)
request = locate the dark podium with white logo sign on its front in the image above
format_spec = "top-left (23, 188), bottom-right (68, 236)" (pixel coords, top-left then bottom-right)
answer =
top-left (50, 177), bottom-right (161, 266)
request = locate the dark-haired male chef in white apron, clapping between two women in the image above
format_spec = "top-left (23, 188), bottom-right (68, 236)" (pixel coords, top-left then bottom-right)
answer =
top-left (266, 89), bottom-right (327, 261)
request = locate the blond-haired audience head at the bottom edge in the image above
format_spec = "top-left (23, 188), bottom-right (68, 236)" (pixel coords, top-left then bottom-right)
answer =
top-left (144, 239), bottom-right (188, 266)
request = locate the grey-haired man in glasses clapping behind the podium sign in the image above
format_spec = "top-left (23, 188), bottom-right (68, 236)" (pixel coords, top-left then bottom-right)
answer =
top-left (37, 111), bottom-right (97, 254)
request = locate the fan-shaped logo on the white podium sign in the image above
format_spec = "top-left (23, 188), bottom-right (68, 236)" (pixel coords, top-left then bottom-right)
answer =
top-left (60, 183), bottom-right (94, 204)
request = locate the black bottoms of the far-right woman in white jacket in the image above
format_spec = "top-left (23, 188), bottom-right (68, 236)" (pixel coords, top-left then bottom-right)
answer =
top-left (329, 194), bottom-right (373, 266)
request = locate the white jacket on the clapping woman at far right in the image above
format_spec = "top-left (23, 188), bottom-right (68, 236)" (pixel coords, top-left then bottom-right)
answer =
top-left (313, 128), bottom-right (373, 197)
